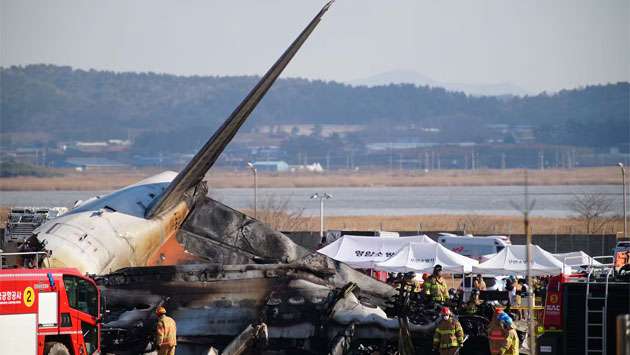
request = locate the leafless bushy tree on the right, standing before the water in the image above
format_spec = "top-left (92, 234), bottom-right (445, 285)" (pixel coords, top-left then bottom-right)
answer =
top-left (566, 193), bottom-right (613, 234)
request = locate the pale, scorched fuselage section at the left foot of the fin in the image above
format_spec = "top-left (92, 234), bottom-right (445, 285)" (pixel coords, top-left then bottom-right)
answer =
top-left (34, 171), bottom-right (189, 274)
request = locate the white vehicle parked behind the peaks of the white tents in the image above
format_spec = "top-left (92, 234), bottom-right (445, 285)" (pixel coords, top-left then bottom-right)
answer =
top-left (438, 233), bottom-right (512, 261)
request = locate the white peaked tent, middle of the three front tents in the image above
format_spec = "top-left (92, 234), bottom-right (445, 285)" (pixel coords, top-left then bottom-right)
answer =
top-left (374, 243), bottom-right (479, 273)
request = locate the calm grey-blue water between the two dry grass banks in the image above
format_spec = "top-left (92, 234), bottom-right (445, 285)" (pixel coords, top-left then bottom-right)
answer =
top-left (0, 185), bottom-right (622, 217)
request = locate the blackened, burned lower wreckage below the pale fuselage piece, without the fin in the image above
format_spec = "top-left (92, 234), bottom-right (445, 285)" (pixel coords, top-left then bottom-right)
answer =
top-left (99, 192), bottom-right (450, 353)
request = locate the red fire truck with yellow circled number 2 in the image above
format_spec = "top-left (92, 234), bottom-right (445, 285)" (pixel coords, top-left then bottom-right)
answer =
top-left (0, 268), bottom-right (101, 355)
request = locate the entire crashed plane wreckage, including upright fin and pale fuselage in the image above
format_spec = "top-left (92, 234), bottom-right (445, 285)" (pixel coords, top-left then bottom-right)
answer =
top-left (25, 3), bottom-right (498, 354)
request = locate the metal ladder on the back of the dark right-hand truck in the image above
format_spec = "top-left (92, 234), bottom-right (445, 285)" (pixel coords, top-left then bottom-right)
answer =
top-left (584, 264), bottom-right (614, 355)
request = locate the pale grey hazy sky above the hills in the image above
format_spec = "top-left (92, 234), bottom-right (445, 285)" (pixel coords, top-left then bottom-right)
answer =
top-left (0, 0), bottom-right (630, 92)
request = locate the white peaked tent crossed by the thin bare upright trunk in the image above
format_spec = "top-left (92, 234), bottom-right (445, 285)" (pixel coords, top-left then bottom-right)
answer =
top-left (472, 245), bottom-right (570, 276)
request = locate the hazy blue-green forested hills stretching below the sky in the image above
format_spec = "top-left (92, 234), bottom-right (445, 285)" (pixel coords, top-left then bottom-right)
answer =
top-left (0, 65), bottom-right (630, 147)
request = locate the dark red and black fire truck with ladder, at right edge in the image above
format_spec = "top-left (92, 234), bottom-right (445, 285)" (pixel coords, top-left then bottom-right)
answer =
top-left (537, 242), bottom-right (630, 355)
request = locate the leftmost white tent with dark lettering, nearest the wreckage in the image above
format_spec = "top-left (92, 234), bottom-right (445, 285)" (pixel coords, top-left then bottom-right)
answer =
top-left (318, 235), bottom-right (436, 269)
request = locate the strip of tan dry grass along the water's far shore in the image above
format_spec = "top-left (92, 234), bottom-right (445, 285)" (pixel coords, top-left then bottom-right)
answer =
top-left (0, 167), bottom-right (620, 190)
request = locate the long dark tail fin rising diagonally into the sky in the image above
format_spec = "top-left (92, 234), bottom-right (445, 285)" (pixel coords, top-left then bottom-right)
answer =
top-left (146, 0), bottom-right (334, 218)
